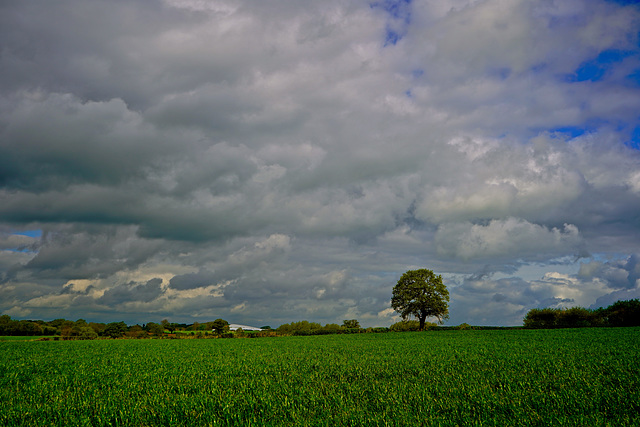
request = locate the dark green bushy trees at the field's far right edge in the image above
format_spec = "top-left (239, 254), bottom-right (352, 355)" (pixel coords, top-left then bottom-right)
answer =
top-left (524, 299), bottom-right (640, 329)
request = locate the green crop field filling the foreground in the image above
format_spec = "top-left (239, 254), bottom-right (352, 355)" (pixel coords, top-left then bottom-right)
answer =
top-left (0, 328), bottom-right (640, 426)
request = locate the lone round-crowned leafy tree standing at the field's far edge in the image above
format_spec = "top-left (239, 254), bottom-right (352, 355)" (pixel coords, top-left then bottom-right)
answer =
top-left (391, 269), bottom-right (449, 330)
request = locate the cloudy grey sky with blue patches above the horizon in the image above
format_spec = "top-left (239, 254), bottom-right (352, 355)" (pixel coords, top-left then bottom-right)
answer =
top-left (0, 0), bottom-right (640, 327)
